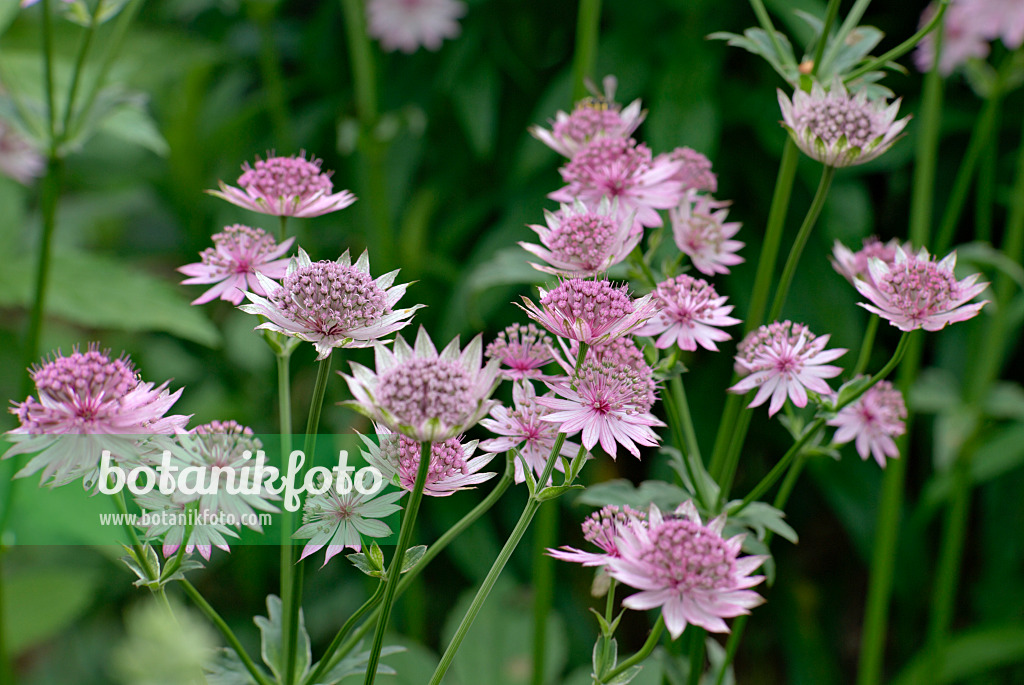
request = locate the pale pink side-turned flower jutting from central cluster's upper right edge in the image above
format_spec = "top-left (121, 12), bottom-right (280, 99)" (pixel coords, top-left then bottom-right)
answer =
top-left (669, 190), bottom-right (743, 275)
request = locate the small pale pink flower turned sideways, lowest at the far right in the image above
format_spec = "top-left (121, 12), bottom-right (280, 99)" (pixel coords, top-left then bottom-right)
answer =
top-left (828, 381), bottom-right (906, 468)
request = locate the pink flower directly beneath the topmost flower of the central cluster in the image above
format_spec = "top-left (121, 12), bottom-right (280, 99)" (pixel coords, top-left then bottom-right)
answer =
top-left (548, 137), bottom-right (683, 232)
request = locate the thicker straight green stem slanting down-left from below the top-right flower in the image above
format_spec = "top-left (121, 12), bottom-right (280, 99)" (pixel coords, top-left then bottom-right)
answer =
top-left (708, 136), bottom-right (800, 481)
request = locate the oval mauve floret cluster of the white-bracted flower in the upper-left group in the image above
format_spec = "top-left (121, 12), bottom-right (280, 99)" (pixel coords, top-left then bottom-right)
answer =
top-left (270, 261), bottom-right (388, 334)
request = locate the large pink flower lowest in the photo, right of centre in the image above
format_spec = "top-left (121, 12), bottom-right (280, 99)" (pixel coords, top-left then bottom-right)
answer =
top-left (606, 502), bottom-right (766, 639)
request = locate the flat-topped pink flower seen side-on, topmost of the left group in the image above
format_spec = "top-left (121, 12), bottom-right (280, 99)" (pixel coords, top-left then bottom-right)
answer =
top-left (207, 152), bottom-right (355, 218)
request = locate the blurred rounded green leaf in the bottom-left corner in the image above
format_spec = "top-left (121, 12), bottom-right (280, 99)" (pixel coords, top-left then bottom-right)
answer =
top-left (2, 568), bottom-right (99, 654)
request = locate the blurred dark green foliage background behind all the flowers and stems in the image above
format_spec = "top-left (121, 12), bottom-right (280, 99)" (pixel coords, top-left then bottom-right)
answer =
top-left (0, 0), bottom-right (1024, 685)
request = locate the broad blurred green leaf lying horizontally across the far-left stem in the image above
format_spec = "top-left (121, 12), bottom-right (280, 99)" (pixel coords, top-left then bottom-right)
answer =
top-left (0, 252), bottom-right (220, 347)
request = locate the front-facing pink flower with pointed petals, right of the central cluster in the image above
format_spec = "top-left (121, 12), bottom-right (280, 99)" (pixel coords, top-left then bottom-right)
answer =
top-left (729, 322), bottom-right (846, 416)
